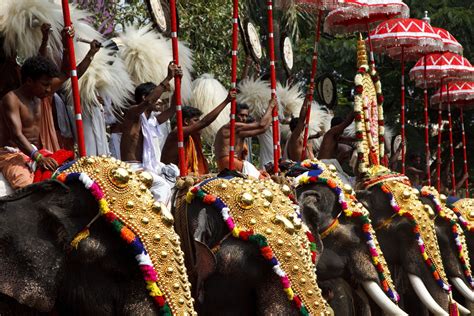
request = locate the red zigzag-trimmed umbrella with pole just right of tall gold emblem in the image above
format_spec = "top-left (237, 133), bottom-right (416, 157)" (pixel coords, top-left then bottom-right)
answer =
top-left (370, 19), bottom-right (441, 173)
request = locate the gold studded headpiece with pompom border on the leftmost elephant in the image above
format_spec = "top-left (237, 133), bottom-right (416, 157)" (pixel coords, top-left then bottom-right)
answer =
top-left (56, 157), bottom-right (196, 315)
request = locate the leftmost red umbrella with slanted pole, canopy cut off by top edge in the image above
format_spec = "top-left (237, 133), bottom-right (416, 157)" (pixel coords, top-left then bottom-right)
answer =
top-left (296, 0), bottom-right (342, 161)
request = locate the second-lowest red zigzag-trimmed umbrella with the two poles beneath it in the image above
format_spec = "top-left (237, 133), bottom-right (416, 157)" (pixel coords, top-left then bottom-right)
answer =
top-left (410, 52), bottom-right (474, 194)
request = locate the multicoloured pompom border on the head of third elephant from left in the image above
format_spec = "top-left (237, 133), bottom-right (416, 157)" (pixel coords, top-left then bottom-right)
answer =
top-left (295, 159), bottom-right (400, 303)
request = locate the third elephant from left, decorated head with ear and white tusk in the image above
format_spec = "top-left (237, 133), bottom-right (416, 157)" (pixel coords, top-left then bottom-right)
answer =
top-left (295, 160), bottom-right (404, 314)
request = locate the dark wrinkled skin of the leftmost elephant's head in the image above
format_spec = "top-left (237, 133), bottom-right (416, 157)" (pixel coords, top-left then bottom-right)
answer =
top-left (0, 181), bottom-right (157, 316)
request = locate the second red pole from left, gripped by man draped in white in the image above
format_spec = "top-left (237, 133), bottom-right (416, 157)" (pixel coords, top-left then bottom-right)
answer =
top-left (169, 0), bottom-right (188, 177)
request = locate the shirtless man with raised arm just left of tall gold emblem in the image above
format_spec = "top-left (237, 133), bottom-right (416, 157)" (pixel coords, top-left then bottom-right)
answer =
top-left (318, 112), bottom-right (355, 160)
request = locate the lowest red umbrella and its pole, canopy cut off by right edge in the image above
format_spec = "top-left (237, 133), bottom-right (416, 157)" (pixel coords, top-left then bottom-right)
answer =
top-left (431, 82), bottom-right (474, 198)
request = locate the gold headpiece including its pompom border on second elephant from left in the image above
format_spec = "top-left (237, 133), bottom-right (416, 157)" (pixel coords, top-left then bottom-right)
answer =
top-left (187, 178), bottom-right (330, 315)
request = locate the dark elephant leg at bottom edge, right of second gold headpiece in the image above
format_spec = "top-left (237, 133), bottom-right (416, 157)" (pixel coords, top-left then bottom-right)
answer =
top-left (318, 278), bottom-right (357, 316)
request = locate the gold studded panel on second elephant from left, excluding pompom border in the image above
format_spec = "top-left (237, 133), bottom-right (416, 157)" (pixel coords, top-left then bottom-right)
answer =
top-left (202, 178), bottom-right (330, 315)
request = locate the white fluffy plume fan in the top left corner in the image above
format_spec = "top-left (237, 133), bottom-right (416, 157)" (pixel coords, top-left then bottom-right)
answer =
top-left (0, 0), bottom-right (102, 60)
